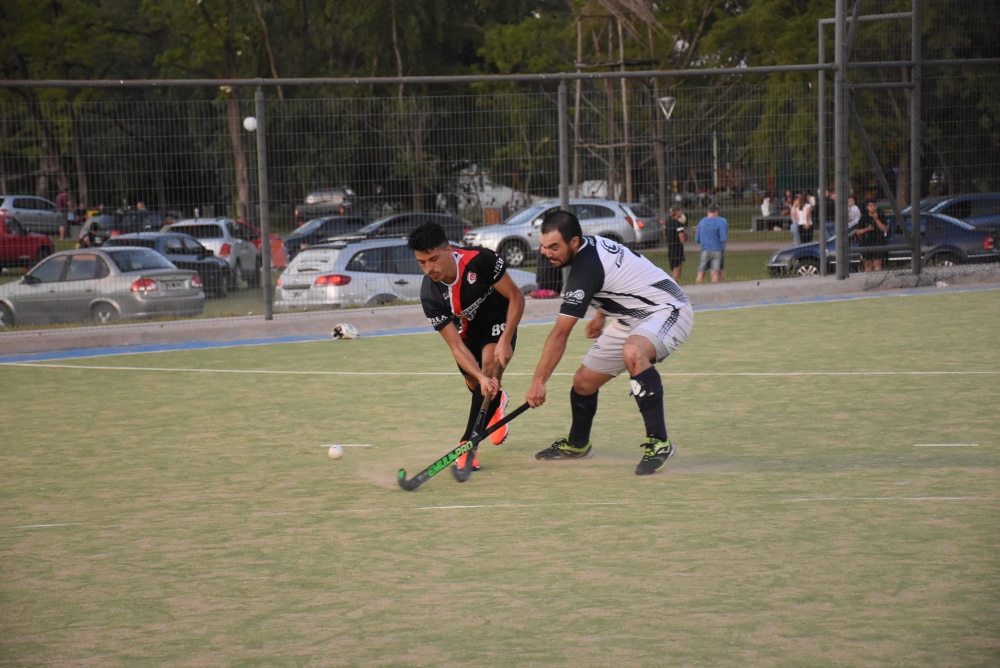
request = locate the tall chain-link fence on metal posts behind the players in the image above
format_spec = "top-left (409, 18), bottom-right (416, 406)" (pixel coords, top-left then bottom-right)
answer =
top-left (0, 41), bottom-right (1000, 325)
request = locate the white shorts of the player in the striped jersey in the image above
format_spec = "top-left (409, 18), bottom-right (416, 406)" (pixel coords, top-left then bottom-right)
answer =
top-left (583, 304), bottom-right (694, 377)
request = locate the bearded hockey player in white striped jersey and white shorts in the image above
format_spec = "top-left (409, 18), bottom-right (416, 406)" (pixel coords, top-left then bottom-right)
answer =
top-left (525, 211), bottom-right (693, 475)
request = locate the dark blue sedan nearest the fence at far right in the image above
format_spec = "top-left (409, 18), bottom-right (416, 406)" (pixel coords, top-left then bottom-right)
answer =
top-left (767, 214), bottom-right (1000, 276)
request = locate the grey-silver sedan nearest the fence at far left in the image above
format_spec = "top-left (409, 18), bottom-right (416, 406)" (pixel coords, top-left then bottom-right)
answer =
top-left (0, 246), bottom-right (205, 328)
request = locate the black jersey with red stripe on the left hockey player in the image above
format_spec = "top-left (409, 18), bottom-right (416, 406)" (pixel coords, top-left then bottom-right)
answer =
top-left (420, 247), bottom-right (507, 338)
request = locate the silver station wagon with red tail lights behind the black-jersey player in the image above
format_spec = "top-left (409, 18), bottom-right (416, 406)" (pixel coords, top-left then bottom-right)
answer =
top-left (274, 239), bottom-right (536, 311)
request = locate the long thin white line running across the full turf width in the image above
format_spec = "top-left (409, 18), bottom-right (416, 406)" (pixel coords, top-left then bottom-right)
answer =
top-left (0, 362), bottom-right (1000, 378)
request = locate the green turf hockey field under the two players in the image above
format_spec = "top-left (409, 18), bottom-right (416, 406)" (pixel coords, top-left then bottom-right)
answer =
top-left (0, 291), bottom-right (1000, 668)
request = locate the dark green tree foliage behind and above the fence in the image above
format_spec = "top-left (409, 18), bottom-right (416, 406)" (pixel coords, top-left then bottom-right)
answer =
top-left (0, 0), bottom-right (1000, 214)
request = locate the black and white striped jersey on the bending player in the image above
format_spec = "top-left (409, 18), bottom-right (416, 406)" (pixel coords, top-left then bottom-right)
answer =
top-left (559, 236), bottom-right (688, 327)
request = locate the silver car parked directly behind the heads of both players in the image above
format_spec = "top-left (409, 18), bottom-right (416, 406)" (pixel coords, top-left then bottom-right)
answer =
top-left (462, 199), bottom-right (638, 267)
